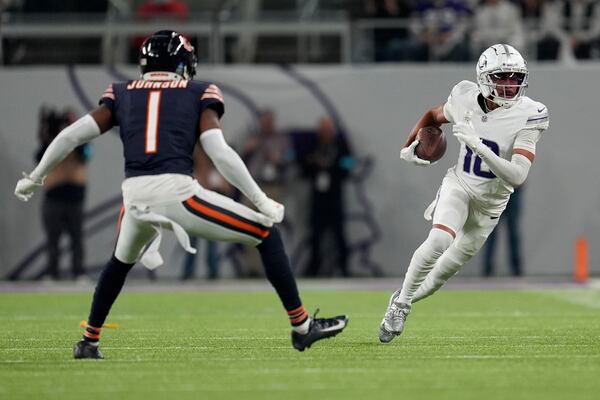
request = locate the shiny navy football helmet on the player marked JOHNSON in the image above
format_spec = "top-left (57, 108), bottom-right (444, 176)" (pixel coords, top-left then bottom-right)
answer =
top-left (140, 31), bottom-right (196, 79)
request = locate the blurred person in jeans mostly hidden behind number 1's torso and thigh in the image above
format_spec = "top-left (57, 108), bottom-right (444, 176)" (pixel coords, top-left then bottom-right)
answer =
top-left (181, 144), bottom-right (233, 281)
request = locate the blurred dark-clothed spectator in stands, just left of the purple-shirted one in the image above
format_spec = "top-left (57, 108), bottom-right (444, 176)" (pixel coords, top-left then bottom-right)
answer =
top-left (365, 0), bottom-right (411, 62)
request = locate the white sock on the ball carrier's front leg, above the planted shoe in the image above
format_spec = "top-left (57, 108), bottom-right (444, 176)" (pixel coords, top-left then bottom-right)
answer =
top-left (396, 229), bottom-right (453, 304)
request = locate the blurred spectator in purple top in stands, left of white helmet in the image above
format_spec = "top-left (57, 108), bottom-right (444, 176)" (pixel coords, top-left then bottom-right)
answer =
top-left (415, 0), bottom-right (471, 62)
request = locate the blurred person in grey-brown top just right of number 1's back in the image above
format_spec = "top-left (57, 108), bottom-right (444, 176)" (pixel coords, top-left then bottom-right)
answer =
top-left (241, 110), bottom-right (293, 276)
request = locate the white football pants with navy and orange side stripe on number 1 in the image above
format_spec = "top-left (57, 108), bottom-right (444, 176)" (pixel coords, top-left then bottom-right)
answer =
top-left (115, 175), bottom-right (272, 263)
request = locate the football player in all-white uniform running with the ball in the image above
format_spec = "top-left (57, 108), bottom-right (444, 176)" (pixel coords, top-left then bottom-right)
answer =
top-left (379, 44), bottom-right (548, 343)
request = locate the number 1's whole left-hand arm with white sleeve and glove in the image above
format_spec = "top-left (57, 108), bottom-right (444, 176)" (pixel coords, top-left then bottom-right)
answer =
top-left (15, 106), bottom-right (112, 201)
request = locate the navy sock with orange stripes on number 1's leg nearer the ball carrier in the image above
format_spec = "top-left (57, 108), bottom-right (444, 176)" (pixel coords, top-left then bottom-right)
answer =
top-left (256, 227), bottom-right (308, 318)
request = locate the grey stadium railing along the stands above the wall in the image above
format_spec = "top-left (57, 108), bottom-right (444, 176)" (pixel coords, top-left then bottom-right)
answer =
top-left (0, 11), bottom-right (572, 65)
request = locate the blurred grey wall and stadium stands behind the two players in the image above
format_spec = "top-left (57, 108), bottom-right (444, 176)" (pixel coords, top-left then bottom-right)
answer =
top-left (0, 0), bottom-right (600, 279)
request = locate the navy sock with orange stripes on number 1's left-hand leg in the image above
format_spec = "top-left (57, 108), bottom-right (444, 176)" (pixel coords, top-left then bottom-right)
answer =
top-left (84, 255), bottom-right (134, 341)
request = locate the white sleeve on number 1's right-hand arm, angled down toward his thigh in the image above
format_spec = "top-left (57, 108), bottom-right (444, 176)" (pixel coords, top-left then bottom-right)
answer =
top-left (200, 128), bottom-right (265, 204)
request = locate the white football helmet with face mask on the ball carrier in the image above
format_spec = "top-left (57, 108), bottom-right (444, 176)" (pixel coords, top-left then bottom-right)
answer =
top-left (475, 44), bottom-right (529, 108)
